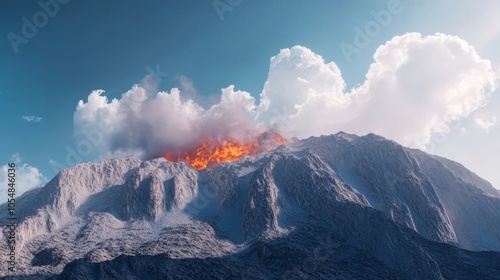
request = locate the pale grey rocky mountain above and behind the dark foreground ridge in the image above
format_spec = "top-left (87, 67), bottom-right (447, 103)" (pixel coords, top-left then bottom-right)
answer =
top-left (0, 132), bottom-right (500, 279)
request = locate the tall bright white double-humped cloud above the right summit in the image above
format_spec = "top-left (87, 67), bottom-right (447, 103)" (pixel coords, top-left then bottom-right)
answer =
top-left (259, 33), bottom-right (497, 148)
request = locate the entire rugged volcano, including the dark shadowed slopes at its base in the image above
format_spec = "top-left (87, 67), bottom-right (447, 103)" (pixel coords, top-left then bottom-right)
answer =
top-left (0, 133), bottom-right (500, 279)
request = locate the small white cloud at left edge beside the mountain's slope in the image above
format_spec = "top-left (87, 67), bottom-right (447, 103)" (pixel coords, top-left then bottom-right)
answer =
top-left (0, 154), bottom-right (47, 198)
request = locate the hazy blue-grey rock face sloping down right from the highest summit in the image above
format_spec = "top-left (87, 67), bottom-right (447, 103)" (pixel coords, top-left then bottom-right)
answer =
top-left (304, 133), bottom-right (500, 251)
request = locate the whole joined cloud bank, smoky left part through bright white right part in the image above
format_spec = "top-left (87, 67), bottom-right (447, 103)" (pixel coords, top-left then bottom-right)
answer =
top-left (74, 33), bottom-right (498, 160)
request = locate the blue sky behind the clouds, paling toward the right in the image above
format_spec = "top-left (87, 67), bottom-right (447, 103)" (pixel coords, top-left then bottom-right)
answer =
top-left (0, 0), bottom-right (500, 195)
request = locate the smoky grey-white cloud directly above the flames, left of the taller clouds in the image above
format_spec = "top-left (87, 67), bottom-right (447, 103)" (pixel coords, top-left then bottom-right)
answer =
top-left (74, 85), bottom-right (257, 157)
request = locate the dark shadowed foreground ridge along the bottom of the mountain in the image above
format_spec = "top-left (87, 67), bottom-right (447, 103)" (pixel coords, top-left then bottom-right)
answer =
top-left (55, 228), bottom-right (500, 280)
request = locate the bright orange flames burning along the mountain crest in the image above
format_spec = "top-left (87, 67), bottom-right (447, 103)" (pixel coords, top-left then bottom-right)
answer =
top-left (165, 132), bottom-right (287, 170)
